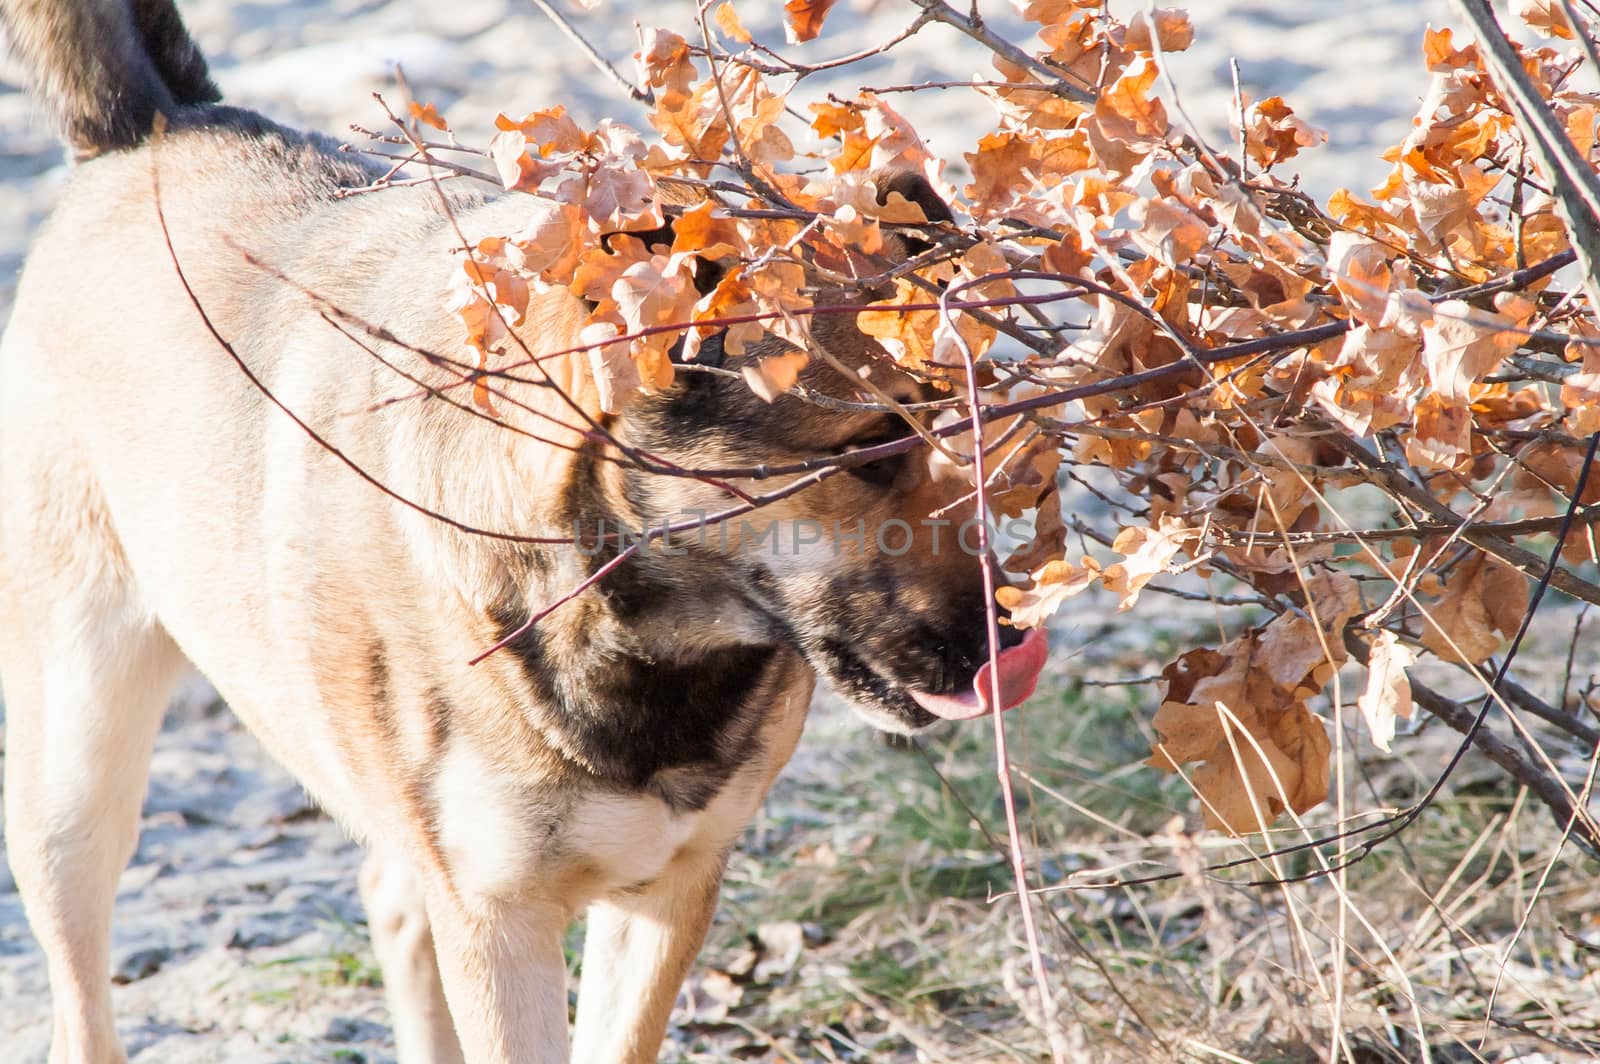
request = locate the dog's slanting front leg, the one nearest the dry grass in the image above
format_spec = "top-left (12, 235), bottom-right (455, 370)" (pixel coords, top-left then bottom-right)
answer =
top-left (573, 851), bottom-right (725, 1064)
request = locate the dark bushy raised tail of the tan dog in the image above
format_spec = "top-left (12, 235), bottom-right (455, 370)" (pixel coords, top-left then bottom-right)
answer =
top-left (0, 0), bottom-right (221, 158)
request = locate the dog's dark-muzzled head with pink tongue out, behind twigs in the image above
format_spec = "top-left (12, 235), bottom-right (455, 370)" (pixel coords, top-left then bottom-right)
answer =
top-left (579, 176), bottom-right (1045, 731)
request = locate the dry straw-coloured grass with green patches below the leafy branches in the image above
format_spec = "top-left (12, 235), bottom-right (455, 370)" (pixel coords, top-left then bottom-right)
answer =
top-left (649, 592), bottom-right (1600, 1062)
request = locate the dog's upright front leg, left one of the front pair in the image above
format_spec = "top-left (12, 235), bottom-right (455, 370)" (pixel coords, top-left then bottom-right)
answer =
top-left (427, 891), bottom-right (570, 1064)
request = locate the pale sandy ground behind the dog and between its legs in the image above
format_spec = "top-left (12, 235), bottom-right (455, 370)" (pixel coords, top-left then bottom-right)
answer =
top-left (0, 0), bottom-right (1465, 1064)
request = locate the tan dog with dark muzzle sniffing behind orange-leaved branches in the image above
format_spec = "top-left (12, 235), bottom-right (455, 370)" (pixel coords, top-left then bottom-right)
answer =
top-left (0, 0), bottom-right (1043, 1064)
